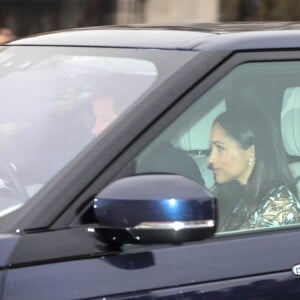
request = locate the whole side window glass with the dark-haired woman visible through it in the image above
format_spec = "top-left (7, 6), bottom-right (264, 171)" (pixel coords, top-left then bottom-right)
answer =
top-left (135, 61), bottom-right (300, 234)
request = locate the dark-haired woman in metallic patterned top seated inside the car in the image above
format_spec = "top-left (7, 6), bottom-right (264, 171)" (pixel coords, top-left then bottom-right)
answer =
top-left (208, 109), bottom-right (300, 232)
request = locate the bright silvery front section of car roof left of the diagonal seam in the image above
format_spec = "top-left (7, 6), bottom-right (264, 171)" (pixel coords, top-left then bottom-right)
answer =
top-left (12, 29), bottom-right (213, 50)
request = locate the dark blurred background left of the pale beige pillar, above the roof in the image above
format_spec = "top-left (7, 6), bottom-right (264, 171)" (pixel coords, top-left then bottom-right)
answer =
top-left (0, 0), bottom-right (117, 37)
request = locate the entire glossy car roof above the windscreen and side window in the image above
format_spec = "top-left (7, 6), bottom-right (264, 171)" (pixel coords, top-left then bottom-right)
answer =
top-left (9, 22), bottom-right (300, 51)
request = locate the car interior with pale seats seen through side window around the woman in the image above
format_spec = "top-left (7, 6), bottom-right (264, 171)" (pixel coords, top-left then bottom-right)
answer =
top-left (136, 62), bottom-right (300, 212)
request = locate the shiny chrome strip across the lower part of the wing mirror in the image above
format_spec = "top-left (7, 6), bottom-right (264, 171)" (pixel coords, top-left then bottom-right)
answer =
top-left (134, 220), bottom-right (215, 231)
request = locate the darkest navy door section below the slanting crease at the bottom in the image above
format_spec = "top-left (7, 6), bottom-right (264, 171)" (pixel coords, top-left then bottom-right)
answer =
top-left (108, 272), bottom-right (299, 300)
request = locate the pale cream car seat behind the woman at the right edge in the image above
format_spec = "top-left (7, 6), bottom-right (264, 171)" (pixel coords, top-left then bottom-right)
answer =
top-left (281, 87), bottom-right (300, 196)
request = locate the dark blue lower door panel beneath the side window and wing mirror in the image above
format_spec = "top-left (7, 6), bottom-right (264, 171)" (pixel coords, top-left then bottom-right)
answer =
top-left (5, 230), bottom-right (299, 299)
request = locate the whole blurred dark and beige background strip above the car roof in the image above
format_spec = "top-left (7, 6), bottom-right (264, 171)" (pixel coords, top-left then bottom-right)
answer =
top-left (0, 0), bottom-right (300, 37)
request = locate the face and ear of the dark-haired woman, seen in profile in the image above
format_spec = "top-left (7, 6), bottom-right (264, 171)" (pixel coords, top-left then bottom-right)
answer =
top-left (208, 123), bottom-right (255, 185)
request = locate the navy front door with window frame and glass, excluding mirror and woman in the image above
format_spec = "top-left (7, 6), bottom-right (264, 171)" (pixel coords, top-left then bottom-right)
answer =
top-left (3, 51), bottom-right (300, 299)
